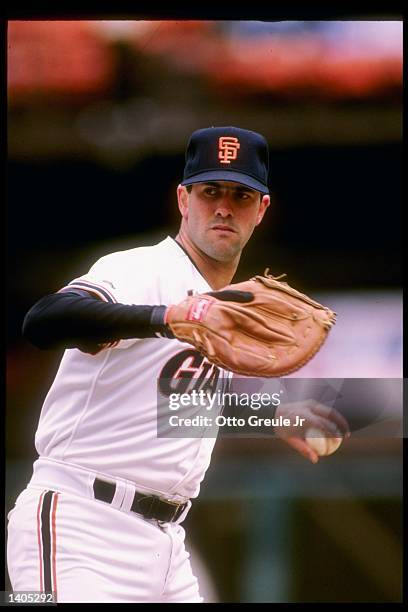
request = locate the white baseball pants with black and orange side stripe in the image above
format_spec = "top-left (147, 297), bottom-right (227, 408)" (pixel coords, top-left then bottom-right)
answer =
top-left (7, 460), bottom-right (202, 603)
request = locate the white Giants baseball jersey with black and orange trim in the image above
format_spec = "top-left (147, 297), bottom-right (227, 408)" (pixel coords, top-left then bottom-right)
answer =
top-left (35, 237), bottom-right (230, 498)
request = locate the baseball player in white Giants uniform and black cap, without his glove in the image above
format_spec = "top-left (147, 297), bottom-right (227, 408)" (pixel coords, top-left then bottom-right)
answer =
top-left (7, 127), bottom-right (347, 603)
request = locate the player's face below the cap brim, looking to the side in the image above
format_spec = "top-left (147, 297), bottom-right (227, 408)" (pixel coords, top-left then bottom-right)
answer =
top-left (178, 181), bottom-right (270, 261)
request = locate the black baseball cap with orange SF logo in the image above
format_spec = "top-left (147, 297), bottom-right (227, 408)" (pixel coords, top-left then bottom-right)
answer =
top-left (181, 126), bottom-right (269, 194)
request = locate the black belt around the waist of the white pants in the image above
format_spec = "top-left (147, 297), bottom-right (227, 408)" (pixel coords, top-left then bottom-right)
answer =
top-left (93, 478), bottom-right (188, 523)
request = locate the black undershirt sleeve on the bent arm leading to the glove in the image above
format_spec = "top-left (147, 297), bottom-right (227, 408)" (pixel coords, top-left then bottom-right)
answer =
top-left (23, 289), bottom-right (173, 353)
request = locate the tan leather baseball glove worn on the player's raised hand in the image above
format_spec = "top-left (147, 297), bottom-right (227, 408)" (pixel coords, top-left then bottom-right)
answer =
top-left (166, 269), bottom-right (336, 377)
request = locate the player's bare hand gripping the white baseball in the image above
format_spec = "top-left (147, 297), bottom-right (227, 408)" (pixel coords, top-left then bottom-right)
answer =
top-left (275, 399), bottom-right (350, 463)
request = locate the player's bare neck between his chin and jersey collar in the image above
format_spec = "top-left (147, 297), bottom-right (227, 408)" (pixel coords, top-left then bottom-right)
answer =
top-left (176, 230), bottom-right (239, 290)
